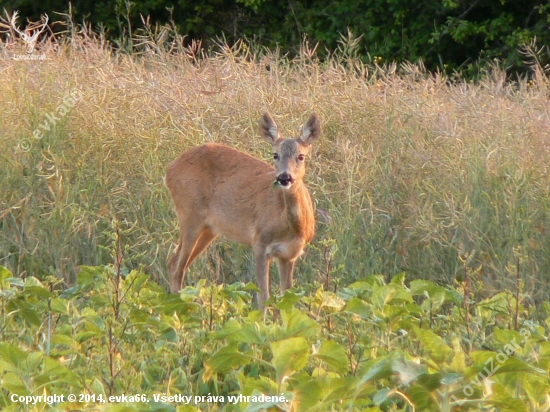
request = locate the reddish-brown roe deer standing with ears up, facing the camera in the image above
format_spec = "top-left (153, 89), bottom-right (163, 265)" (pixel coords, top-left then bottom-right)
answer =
top-left (166, 113), bottom-right (321, 308)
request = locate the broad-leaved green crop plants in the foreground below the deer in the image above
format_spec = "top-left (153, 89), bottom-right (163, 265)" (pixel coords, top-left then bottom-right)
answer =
top-left (0, 266), bottom-right (550, 412)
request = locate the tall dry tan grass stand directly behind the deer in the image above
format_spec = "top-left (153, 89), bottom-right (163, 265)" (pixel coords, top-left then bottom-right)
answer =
top-left (0, 27), bottom-right (550, 301)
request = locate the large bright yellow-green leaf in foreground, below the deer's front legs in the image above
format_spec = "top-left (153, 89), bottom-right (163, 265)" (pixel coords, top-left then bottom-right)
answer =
top-left (271, 337), bottom-right (309, 383)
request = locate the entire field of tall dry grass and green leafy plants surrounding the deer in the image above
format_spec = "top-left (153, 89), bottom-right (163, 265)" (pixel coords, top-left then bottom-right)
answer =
top-left (0, 29), bottom-right (550, 411)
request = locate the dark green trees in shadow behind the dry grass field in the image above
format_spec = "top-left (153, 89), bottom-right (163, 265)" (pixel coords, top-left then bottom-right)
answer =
top-left (7, 0), bottom-right (550, 75)
